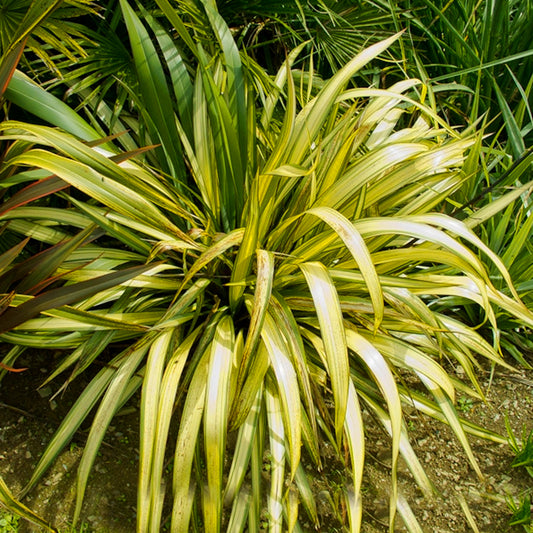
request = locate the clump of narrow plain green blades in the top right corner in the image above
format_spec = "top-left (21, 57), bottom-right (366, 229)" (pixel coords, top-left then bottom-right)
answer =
top-left (397, 0), bottom-right (533, 159)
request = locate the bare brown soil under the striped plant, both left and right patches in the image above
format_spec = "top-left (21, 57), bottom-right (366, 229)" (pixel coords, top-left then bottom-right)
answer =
top-left (0, 354), bottom-right (533, 533)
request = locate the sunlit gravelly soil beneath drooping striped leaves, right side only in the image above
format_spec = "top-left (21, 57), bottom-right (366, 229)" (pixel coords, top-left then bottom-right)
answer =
top-left (363, 371), bottom-right (533, 533)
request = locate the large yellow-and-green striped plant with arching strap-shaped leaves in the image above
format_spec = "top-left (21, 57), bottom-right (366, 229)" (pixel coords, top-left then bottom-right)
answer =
top-left (2, 0), bottom-right (533, 531)
